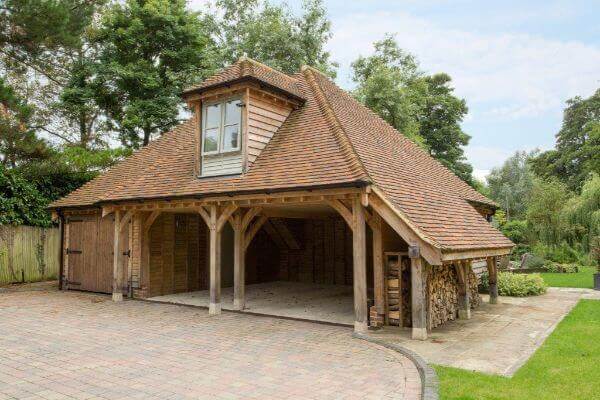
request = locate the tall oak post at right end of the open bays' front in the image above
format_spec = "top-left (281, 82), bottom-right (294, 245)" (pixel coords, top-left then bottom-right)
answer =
top-left (352, 197), bottom-right (367, 332)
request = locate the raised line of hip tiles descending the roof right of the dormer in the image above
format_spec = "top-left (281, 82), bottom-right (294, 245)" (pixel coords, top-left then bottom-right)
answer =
top-left (301, 66), bottom-right (373, 182)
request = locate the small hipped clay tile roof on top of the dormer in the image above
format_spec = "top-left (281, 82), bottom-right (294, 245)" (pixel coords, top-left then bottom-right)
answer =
top-left (183, 56), bottom-right (305, 100)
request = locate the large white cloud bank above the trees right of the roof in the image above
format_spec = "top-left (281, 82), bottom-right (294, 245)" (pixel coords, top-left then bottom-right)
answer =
top-left (329, 11), bottom-right (600, 118)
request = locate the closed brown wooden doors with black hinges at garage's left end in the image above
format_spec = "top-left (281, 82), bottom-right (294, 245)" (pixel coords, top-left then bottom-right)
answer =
top-left (65, 210), bottom-right (129, 293)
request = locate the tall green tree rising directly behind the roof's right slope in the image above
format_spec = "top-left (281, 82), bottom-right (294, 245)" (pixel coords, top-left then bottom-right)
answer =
top-left (352, 35), bottom-right (473, 184)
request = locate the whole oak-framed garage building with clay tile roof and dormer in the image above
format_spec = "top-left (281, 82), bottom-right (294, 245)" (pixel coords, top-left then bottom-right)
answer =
top-left (51, 58), bottom-right (512, 338)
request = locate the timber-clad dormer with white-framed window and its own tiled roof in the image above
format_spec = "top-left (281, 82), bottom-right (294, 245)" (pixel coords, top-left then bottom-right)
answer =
top-left (183, 57), bottom-right (304, 178)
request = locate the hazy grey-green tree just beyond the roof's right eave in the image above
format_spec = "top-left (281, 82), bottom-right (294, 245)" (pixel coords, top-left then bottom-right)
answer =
top-left (487, 151), bottom-right (536, 220)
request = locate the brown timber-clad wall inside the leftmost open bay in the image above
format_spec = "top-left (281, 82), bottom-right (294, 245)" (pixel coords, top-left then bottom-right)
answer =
top-left (148, 213), bottom-right (208, 297)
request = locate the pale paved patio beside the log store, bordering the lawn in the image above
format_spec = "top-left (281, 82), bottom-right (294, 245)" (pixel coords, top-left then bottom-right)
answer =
top-left (369, 288), bottom-right (600, 376)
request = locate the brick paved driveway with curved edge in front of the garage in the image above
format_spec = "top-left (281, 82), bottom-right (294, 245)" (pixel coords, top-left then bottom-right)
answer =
top-left (0, 291), bottom-right (420, 399)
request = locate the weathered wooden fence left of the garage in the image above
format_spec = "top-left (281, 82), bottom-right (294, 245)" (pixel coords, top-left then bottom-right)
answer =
top-left (0, 226), bottom-right (60, 285)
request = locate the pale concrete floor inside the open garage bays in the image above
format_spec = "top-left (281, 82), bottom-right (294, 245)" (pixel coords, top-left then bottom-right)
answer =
top-left (147, 281), bottom-right (354, 326)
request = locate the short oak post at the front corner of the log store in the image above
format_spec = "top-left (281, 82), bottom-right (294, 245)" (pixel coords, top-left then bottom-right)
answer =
top-left (408, 246), bottom-right (427, 340)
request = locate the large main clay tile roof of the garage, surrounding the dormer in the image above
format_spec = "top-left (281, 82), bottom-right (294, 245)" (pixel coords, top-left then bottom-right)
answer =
top-left (51, 58), bottom-right (513, 251)
